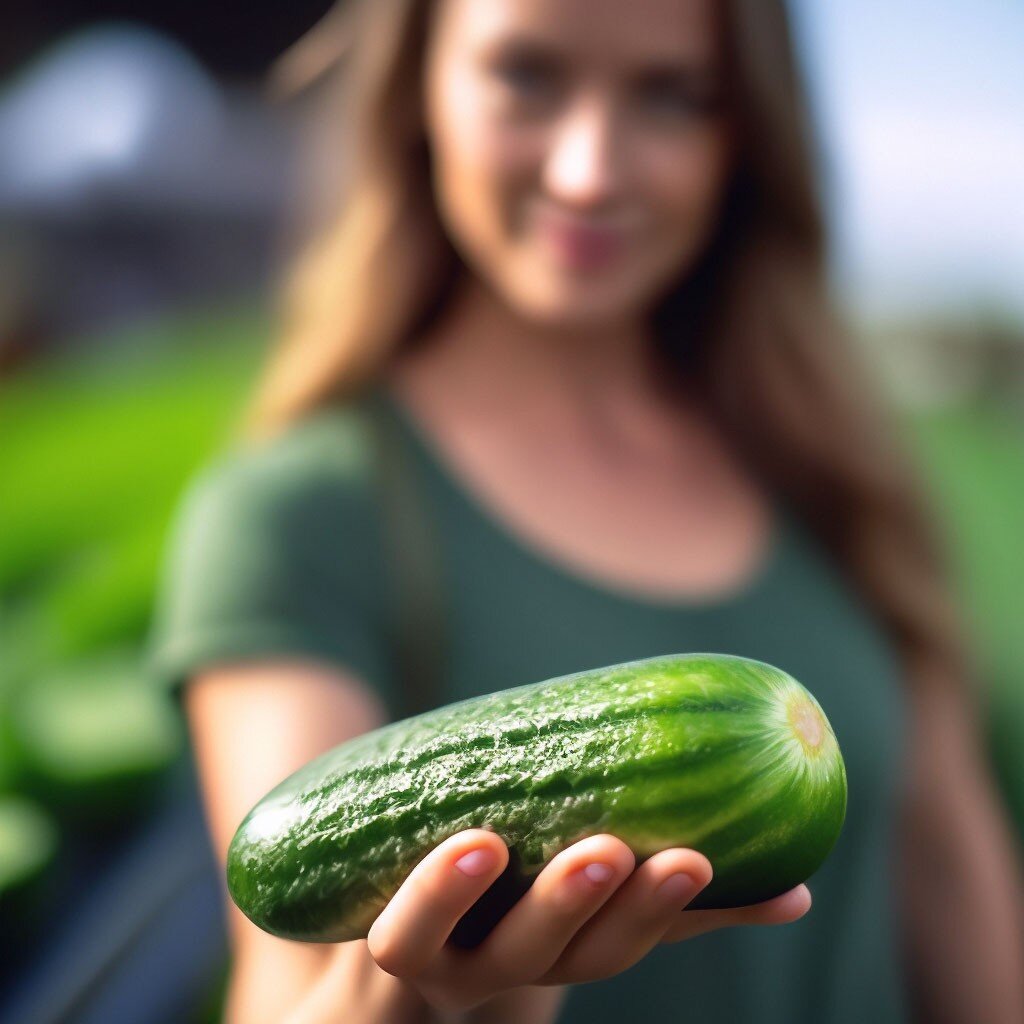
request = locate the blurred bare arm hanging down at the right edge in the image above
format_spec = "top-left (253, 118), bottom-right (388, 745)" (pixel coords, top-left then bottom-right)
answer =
top-left (901, 673), bottom-right (1024, 1024)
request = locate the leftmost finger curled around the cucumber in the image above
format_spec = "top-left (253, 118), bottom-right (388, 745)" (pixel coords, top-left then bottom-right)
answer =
top-left (367, 828), bottom-right (509, 978)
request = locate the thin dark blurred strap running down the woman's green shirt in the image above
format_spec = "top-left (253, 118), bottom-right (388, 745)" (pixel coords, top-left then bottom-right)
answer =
top-left (365, 393), bottom-right (449, 717)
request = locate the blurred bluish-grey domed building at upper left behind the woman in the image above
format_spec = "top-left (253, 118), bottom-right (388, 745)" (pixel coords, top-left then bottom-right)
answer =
top-left (0, 26), bottom-right (294, 364)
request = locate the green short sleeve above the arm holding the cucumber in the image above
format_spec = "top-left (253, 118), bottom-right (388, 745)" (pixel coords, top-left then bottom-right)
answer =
top-left (147, 415), bottom-right (393, 706)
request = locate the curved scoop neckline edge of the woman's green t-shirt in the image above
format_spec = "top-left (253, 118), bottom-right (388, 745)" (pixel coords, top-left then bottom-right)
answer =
top-left (375, 384), bottom-right (787, 613)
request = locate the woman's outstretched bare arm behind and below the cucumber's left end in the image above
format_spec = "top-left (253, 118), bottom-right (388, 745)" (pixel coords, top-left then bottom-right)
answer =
top-left (185, 662), bottom-right (561, 1024)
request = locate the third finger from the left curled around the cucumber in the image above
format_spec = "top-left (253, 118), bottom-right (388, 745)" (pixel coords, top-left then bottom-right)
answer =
top-left (543, 849), bottom-right (713, 984)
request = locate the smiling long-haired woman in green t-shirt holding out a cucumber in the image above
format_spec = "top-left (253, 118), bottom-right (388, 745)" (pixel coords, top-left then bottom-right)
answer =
top-left (148, 0), bottom-right (1024, 1024)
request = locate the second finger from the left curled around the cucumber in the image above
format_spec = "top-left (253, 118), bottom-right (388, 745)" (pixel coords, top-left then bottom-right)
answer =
top-left (474, 836), bottom-right (635, 988)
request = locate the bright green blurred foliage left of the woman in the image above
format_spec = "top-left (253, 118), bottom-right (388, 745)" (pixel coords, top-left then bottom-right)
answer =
top-left (0, 312), bottom-right (267, 897)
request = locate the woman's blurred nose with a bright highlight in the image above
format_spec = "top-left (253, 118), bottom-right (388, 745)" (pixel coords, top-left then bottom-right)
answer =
top-left (544, 99), bottom-right (620, 207)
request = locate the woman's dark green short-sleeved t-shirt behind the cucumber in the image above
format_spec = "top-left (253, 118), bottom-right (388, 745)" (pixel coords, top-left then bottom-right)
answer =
top-left (151, 387), bottom-right (910, 1024)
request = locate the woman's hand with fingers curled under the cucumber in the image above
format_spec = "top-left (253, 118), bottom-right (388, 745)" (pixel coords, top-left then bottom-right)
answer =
top-left (367, 829), bottom-right (811, 1011)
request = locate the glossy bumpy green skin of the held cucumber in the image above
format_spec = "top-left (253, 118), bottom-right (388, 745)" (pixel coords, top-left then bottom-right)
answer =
top-left (227, 654), bottom-right (847, 942)
